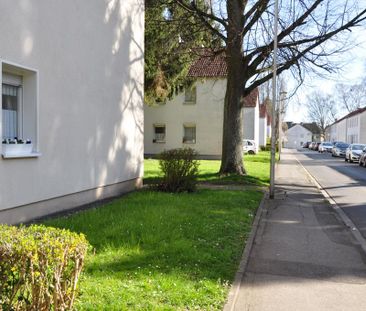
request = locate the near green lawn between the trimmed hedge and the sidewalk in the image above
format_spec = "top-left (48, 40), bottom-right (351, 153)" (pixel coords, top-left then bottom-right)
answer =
top-left (46, 190), bottom-right (262, 310)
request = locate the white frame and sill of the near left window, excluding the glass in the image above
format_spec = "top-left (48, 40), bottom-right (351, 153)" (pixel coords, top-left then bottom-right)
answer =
top-left (0, 58), bottom-right (41, 159)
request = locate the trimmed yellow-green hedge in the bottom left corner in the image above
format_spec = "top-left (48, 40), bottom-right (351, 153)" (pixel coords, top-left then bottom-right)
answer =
top-left (0, 225), bottom-right (88, 310)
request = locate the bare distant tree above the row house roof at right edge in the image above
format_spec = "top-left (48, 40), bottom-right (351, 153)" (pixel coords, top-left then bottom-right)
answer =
top-left (336, 77), bottom-right (366, 112)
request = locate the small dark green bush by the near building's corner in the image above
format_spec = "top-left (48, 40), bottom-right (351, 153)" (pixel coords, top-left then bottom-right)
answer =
top-left (159, 148), bottom-right (199, 192)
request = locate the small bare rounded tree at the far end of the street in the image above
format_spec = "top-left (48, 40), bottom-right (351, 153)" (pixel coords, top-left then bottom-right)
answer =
top-left (306, 91), bottom-right (337, 137)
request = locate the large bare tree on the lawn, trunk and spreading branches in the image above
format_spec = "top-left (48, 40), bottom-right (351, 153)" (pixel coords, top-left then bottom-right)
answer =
top-left (160, 0), bottom-right (366, 174)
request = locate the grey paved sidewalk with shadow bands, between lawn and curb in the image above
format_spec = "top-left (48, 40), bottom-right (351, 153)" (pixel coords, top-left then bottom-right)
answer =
top-left (225, 150), bottom-right (366, 311)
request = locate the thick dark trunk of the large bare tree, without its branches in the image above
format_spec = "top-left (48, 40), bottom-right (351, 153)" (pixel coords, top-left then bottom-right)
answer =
top-left (220, 0), bottom-right (246, 175)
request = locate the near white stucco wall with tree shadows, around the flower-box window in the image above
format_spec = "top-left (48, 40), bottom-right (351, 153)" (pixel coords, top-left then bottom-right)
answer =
top-left (0, 0), bottom-right (144, 210)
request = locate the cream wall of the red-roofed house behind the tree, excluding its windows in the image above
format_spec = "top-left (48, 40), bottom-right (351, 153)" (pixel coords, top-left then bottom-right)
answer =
top-left (144, 79), bottom-right (226, 157)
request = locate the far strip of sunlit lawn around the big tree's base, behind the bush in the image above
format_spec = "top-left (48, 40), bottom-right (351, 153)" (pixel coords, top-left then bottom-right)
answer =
top-left (144, 151), bottom-right (270, 186)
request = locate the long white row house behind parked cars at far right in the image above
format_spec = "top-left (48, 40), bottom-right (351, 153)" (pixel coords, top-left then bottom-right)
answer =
top-left (326, 107), bottom-right (366, 144)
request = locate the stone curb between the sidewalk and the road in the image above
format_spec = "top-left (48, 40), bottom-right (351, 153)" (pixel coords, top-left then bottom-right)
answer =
top-left (295, 156), bottom-right (366, 254)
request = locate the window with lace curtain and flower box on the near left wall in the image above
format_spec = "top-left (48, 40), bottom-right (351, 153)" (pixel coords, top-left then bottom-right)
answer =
top-left (0, 62), bottom-right (39, 158)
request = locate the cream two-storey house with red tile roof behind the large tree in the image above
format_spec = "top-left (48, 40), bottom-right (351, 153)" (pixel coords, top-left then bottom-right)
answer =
top-left (144, 55), bottom-right (259, 159)
